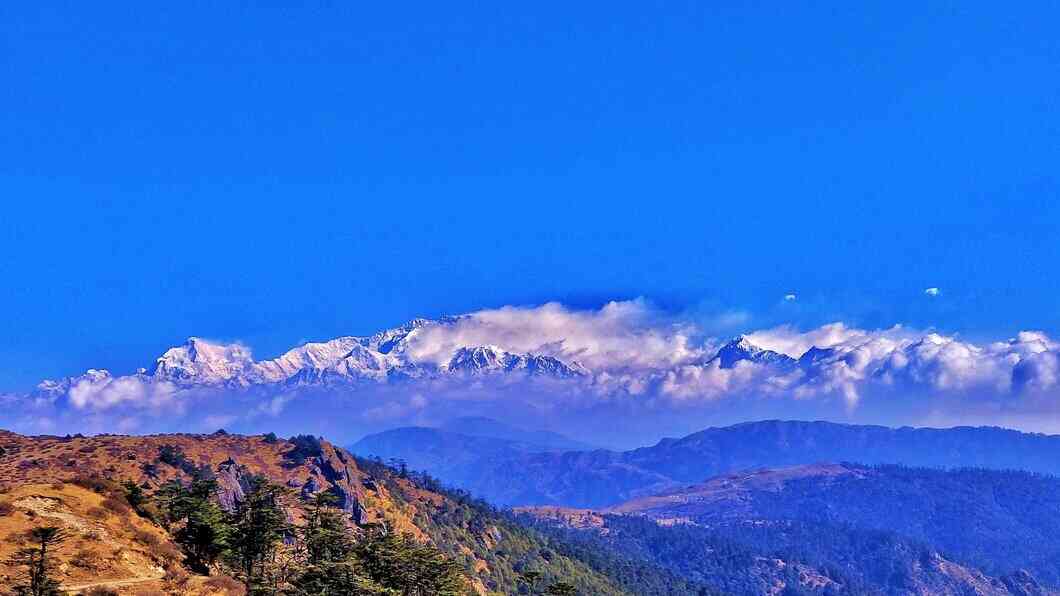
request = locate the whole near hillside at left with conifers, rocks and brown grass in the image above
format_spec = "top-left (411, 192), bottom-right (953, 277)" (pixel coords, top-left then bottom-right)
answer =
top-left (0, 433), bottom-right (663, 595)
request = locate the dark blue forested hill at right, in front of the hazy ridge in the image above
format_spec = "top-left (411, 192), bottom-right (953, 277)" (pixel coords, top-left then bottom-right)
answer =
top-left (522, 463), bottom-right (1060, 595)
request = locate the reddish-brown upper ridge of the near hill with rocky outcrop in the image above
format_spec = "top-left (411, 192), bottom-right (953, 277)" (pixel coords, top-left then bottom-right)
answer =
top-left (0, 432), bottom-right (438, 538)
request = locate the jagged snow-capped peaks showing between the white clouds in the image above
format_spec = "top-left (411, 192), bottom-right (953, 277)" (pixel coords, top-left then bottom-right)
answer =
top-left (32, 317), bottom-right (869, 400)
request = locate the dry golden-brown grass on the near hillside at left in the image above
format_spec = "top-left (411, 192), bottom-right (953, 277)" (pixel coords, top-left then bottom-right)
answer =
top-left (0, 431), bottom-right (481, 596)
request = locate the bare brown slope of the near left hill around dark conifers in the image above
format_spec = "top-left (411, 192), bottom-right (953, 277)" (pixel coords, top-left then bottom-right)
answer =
top-left (0, 431), bottom-right (492, 594)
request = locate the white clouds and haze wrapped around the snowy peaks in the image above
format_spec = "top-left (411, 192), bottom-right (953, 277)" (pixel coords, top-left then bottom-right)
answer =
top-left (7, 300), bottom-right (1060, 439)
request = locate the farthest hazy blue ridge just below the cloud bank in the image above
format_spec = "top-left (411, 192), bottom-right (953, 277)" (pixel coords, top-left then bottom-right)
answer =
top-left (354, 420), bottom-right (1060, 508)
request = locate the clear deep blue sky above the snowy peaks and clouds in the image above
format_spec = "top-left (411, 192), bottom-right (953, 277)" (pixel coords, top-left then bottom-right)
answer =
top-left (0, 1), bottom-right (1060, 389)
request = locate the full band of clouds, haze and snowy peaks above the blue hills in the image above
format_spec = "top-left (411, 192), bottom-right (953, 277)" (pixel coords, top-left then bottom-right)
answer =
top-left (8, 300), bottom-right (1060, 443)
